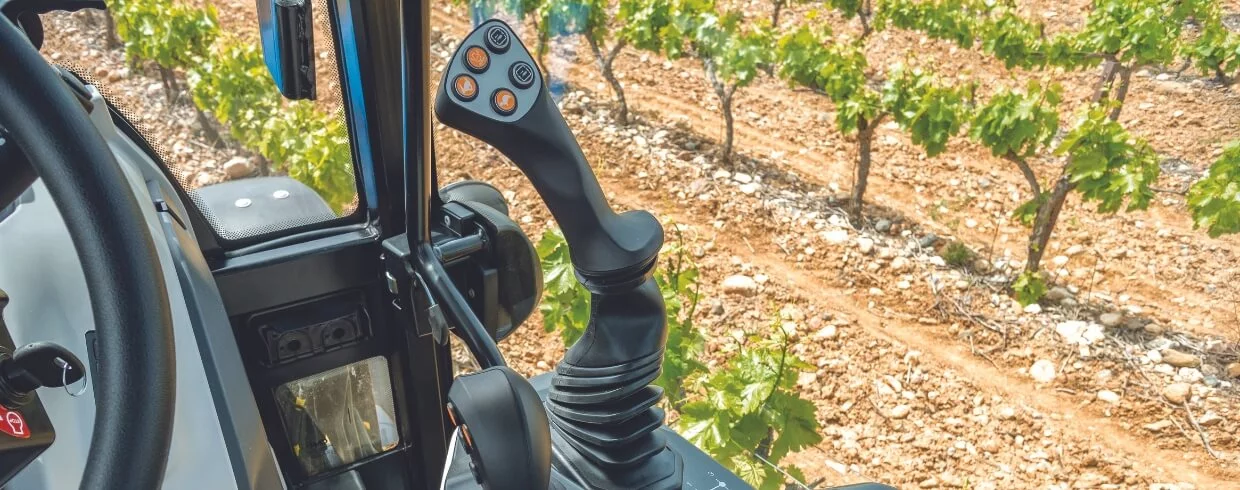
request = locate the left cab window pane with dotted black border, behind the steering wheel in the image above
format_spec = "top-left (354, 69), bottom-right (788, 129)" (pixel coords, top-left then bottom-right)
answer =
top-left (42, 0), bottom-right (358, 243)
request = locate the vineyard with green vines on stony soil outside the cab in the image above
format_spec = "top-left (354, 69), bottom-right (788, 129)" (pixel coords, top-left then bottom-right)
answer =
top-left (33, 0), bottom-right (1240, 489)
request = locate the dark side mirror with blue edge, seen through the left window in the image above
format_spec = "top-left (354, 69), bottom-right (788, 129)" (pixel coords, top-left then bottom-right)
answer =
top-left (258, 0), bottom-right (315, 100)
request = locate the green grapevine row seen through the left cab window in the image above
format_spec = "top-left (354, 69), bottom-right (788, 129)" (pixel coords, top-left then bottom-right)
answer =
top-left (110, 0), bottom-right (356, 213)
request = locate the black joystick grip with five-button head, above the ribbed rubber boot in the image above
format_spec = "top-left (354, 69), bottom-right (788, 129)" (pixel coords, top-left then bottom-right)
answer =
top-left (435, 20), bottom-right (663, 280)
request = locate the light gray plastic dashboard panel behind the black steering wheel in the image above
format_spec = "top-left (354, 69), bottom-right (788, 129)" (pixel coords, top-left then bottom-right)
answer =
top-left (0, 87), bottom-right (284, 489)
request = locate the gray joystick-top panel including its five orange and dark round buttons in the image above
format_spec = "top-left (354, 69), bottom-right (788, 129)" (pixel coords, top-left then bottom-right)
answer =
top-left (443, 20), bottom-right (542, 123)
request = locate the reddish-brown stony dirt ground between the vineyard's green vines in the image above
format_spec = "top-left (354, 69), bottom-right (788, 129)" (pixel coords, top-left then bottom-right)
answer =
top-left (36, 0), bottom-right (1240, 489)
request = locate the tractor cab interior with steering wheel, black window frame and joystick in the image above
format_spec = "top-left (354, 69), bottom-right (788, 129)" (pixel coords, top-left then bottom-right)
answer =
top-left (0, 0), bottom-right (880, 490)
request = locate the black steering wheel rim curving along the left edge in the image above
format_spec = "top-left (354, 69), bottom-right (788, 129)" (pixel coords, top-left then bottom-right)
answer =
top-left (0, 15), bottom-right (175, 490)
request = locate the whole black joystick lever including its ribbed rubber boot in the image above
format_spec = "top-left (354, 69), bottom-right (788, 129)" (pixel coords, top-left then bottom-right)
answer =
top-left (435, 20), bottom-right (684, 490)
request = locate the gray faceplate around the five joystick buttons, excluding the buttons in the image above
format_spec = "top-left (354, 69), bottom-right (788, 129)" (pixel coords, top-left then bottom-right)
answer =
top-left (443, 19), bottom-right (543, 123)
